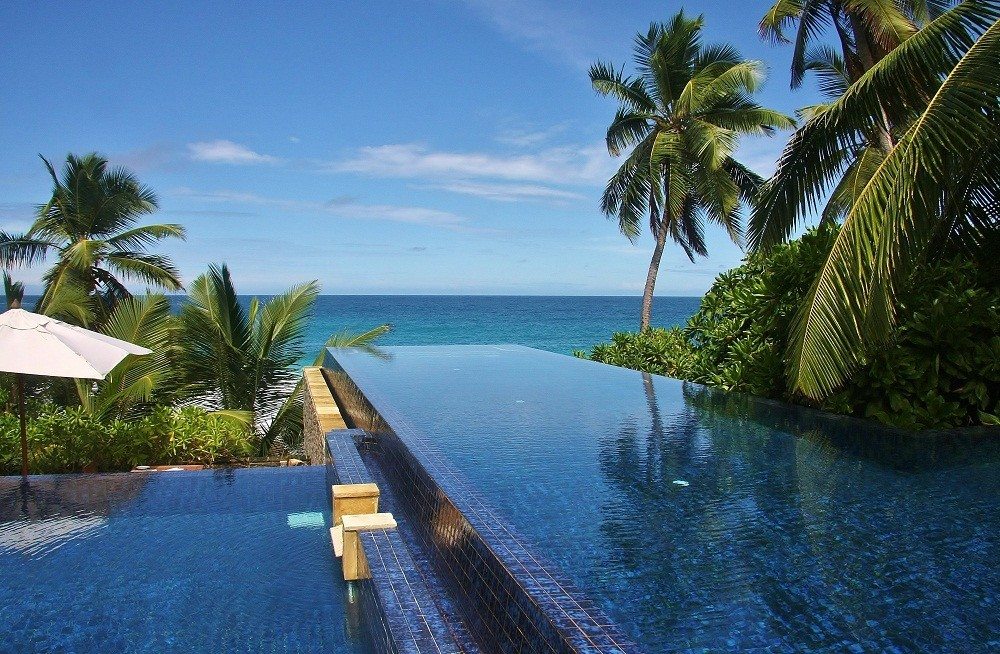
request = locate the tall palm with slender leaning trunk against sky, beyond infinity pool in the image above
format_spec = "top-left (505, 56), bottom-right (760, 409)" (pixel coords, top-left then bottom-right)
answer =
top-left (590, 12), bottom-right (793, 329)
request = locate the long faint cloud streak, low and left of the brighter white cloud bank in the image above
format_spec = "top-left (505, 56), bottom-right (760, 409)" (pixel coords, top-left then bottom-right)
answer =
top-left (168, 187), bottom-right (475, 231)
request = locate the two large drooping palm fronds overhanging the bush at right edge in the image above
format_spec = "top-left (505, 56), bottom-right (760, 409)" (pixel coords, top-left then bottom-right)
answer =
top-left (749, 2), bottom-right (1000, 398)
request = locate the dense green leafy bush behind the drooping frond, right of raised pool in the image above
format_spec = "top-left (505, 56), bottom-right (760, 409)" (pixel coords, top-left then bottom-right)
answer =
top-left (590, 229), bottom-right (1000, 429)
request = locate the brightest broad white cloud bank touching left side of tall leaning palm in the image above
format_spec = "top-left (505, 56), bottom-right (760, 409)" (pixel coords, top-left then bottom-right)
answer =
top-left (328, 143), bottom-right (614, 186)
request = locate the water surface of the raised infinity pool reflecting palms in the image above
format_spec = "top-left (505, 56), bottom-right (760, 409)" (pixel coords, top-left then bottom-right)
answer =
top-left (331, 346), bottom-right (1000, 652)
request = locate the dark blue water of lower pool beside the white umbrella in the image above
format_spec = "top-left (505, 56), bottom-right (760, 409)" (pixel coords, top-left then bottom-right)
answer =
top-left (0, 467), bottom-right (365, 654)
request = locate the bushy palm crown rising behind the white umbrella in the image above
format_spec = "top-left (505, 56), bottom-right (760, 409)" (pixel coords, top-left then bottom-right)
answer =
top-left (0, 153), bottom-right (184, 326)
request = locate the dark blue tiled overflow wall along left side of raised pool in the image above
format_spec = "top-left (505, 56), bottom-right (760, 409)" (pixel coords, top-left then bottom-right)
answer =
top-left (323, 364), bottom-right (637, 653)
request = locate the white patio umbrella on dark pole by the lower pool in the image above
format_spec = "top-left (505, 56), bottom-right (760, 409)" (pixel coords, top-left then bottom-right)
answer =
top-left (0, 303), bottom-right (150, 475)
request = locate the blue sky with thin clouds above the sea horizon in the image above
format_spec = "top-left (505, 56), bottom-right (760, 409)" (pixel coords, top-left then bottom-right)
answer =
top-left (0, 0), bottom-right (816, 295)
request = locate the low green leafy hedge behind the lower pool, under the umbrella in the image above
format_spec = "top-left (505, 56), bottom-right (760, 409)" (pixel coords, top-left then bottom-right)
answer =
top-left (0, 405), bottom-right (254, 474)
